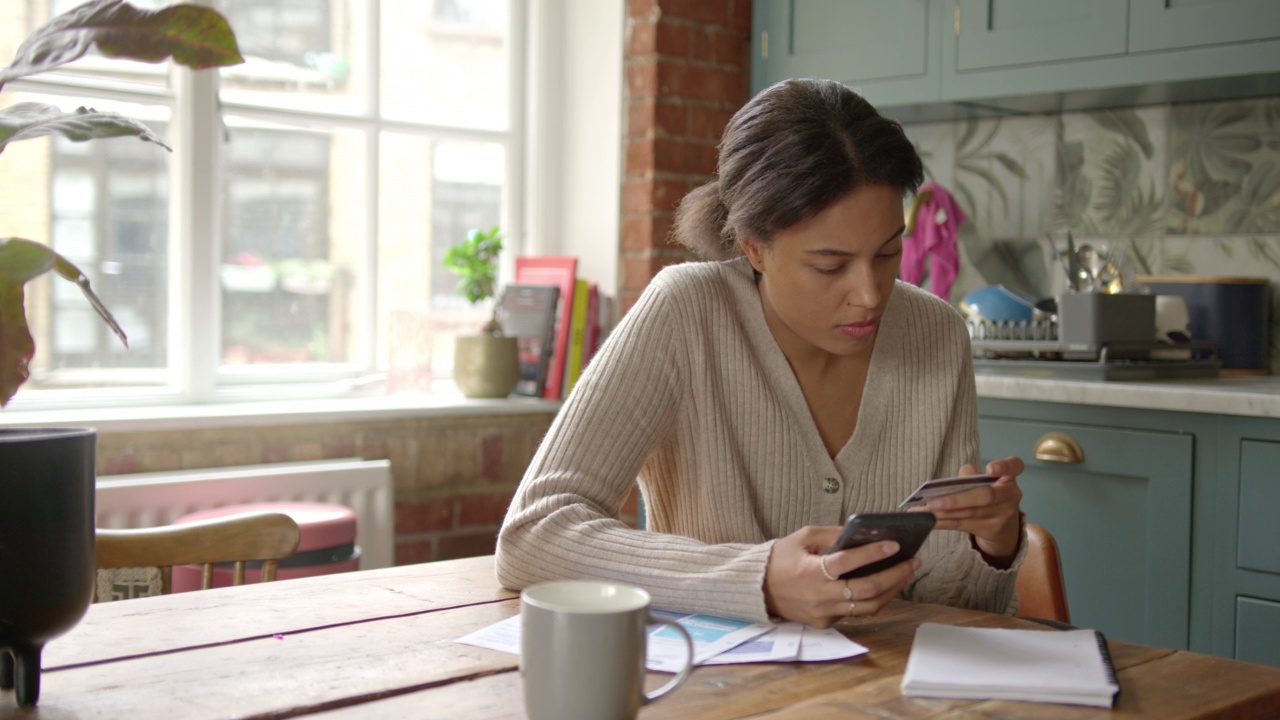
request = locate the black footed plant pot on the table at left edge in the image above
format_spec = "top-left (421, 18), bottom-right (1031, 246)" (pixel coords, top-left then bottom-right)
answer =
top-left (0, 428), bottom-right (97, 706)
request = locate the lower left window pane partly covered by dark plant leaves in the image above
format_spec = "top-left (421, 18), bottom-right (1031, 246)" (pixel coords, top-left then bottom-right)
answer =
top-left (0, 92), bottom-right (169, 393)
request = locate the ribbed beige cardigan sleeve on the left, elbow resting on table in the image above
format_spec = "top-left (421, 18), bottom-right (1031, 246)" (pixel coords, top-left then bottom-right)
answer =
top-left (495, 275), bottom-right (772, 620)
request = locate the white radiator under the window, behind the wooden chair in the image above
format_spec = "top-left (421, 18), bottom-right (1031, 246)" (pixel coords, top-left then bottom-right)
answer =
top-left (96, 459), bottom-right (396, 570)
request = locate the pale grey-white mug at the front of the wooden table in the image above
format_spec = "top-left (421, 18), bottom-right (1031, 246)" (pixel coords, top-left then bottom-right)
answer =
top-left (520, 580), bottom-right (694, 720)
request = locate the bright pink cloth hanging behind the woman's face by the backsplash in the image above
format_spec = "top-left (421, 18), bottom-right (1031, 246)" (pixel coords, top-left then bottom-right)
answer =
top-left (901, 182), bottom-right (965, 301)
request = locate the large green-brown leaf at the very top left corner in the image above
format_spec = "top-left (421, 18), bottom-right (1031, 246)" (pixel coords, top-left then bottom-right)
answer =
top-left (0, 0), bottom-right (244, 87)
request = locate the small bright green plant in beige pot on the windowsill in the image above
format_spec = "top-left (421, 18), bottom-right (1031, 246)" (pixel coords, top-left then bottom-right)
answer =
top-left (444, 227), bottom-right (520, 397)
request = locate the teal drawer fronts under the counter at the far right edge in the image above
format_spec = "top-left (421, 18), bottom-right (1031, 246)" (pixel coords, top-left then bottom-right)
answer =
top-left (1212, 418), bottom-right (1280, 667)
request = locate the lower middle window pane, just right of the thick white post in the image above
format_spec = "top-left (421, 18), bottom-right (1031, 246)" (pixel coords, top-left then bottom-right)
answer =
top-left (219, 119), bottom-right (369, 366)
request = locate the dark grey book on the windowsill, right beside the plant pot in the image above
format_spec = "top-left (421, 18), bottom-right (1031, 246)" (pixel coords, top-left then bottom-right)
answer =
top-left (498, 284), bottom-right (559, 397)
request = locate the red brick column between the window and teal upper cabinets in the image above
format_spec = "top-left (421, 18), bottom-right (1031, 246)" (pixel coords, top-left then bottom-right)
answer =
top-left (618, 0), bottom-right (751, 311)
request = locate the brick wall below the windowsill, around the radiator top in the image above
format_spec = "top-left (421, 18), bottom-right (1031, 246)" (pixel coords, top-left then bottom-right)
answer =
top-left (86, 409), bottom-right (650, 565)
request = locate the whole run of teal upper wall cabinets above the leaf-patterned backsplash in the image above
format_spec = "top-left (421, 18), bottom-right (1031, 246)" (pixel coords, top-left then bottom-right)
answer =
top-left (751, 0), bottom-right (1280, 115)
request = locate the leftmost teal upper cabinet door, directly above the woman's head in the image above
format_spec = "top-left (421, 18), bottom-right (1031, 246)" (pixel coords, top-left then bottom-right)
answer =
top-left (751, 0), bottom-right (947, 105)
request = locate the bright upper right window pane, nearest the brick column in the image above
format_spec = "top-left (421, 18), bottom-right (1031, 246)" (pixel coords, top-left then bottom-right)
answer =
top-left (379, 0), bottom-right (511, 129)
